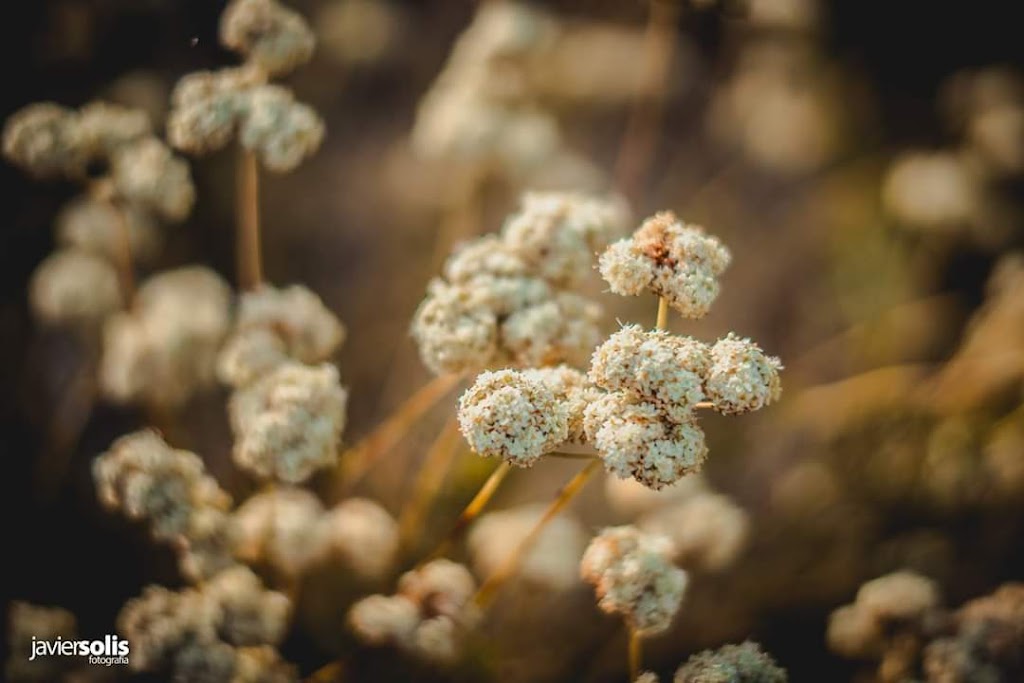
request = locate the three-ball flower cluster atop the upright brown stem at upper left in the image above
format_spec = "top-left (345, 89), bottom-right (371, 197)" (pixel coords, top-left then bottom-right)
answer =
top-left (167, 0), bottom-right (324, 172)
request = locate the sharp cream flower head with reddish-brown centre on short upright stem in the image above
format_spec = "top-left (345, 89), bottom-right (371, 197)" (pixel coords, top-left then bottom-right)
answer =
top-left (600, 211), bottom-right (731, 318)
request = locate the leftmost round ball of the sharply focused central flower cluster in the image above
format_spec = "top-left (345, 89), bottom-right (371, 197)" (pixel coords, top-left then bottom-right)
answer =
top-left (459, 370), bottom-right (568, 467)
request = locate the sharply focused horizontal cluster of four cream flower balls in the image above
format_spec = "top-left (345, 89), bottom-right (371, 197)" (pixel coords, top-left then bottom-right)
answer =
top-left (459, 326), bottom-right (781, 488)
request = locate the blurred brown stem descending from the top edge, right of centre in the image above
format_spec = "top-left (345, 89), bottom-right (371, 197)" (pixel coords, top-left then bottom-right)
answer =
top-left (615, 0), bottom-right (680, 206)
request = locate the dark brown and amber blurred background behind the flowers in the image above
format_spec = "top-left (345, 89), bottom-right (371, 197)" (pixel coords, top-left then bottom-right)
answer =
top-left (0, 0), bottom-right (1024, 681)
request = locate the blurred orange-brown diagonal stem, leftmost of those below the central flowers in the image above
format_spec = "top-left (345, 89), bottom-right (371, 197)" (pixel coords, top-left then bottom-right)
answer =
top-left (336, 374), bottom-right (462, 487)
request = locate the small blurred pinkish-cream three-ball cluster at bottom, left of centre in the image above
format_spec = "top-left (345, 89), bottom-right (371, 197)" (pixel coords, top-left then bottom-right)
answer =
top-left (348, 559), bottom-right (478, 664)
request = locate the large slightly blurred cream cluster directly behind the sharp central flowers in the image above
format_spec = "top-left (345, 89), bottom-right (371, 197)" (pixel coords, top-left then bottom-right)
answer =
top-left (412, 193), bottom-right (625, 375)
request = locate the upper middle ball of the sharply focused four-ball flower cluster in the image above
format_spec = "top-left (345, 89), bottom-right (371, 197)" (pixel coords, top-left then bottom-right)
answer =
top-left (590, 325), bottom-right (711, 423)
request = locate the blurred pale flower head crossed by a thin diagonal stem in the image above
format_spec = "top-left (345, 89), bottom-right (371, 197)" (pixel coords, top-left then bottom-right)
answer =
top-left (467, 505), bottom-right (587, 591)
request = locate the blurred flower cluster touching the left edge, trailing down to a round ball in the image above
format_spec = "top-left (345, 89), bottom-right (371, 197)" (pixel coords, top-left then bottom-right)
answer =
top-left (3, 102), bottom-right (196, 330)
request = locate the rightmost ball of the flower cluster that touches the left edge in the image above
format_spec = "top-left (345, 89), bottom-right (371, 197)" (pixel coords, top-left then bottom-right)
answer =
top-left (111, 137), bottom-right (196, 222)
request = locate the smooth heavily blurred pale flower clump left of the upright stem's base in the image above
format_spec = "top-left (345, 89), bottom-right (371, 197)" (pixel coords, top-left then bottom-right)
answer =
top-left (99, 266), bottom-right (230, 407)
